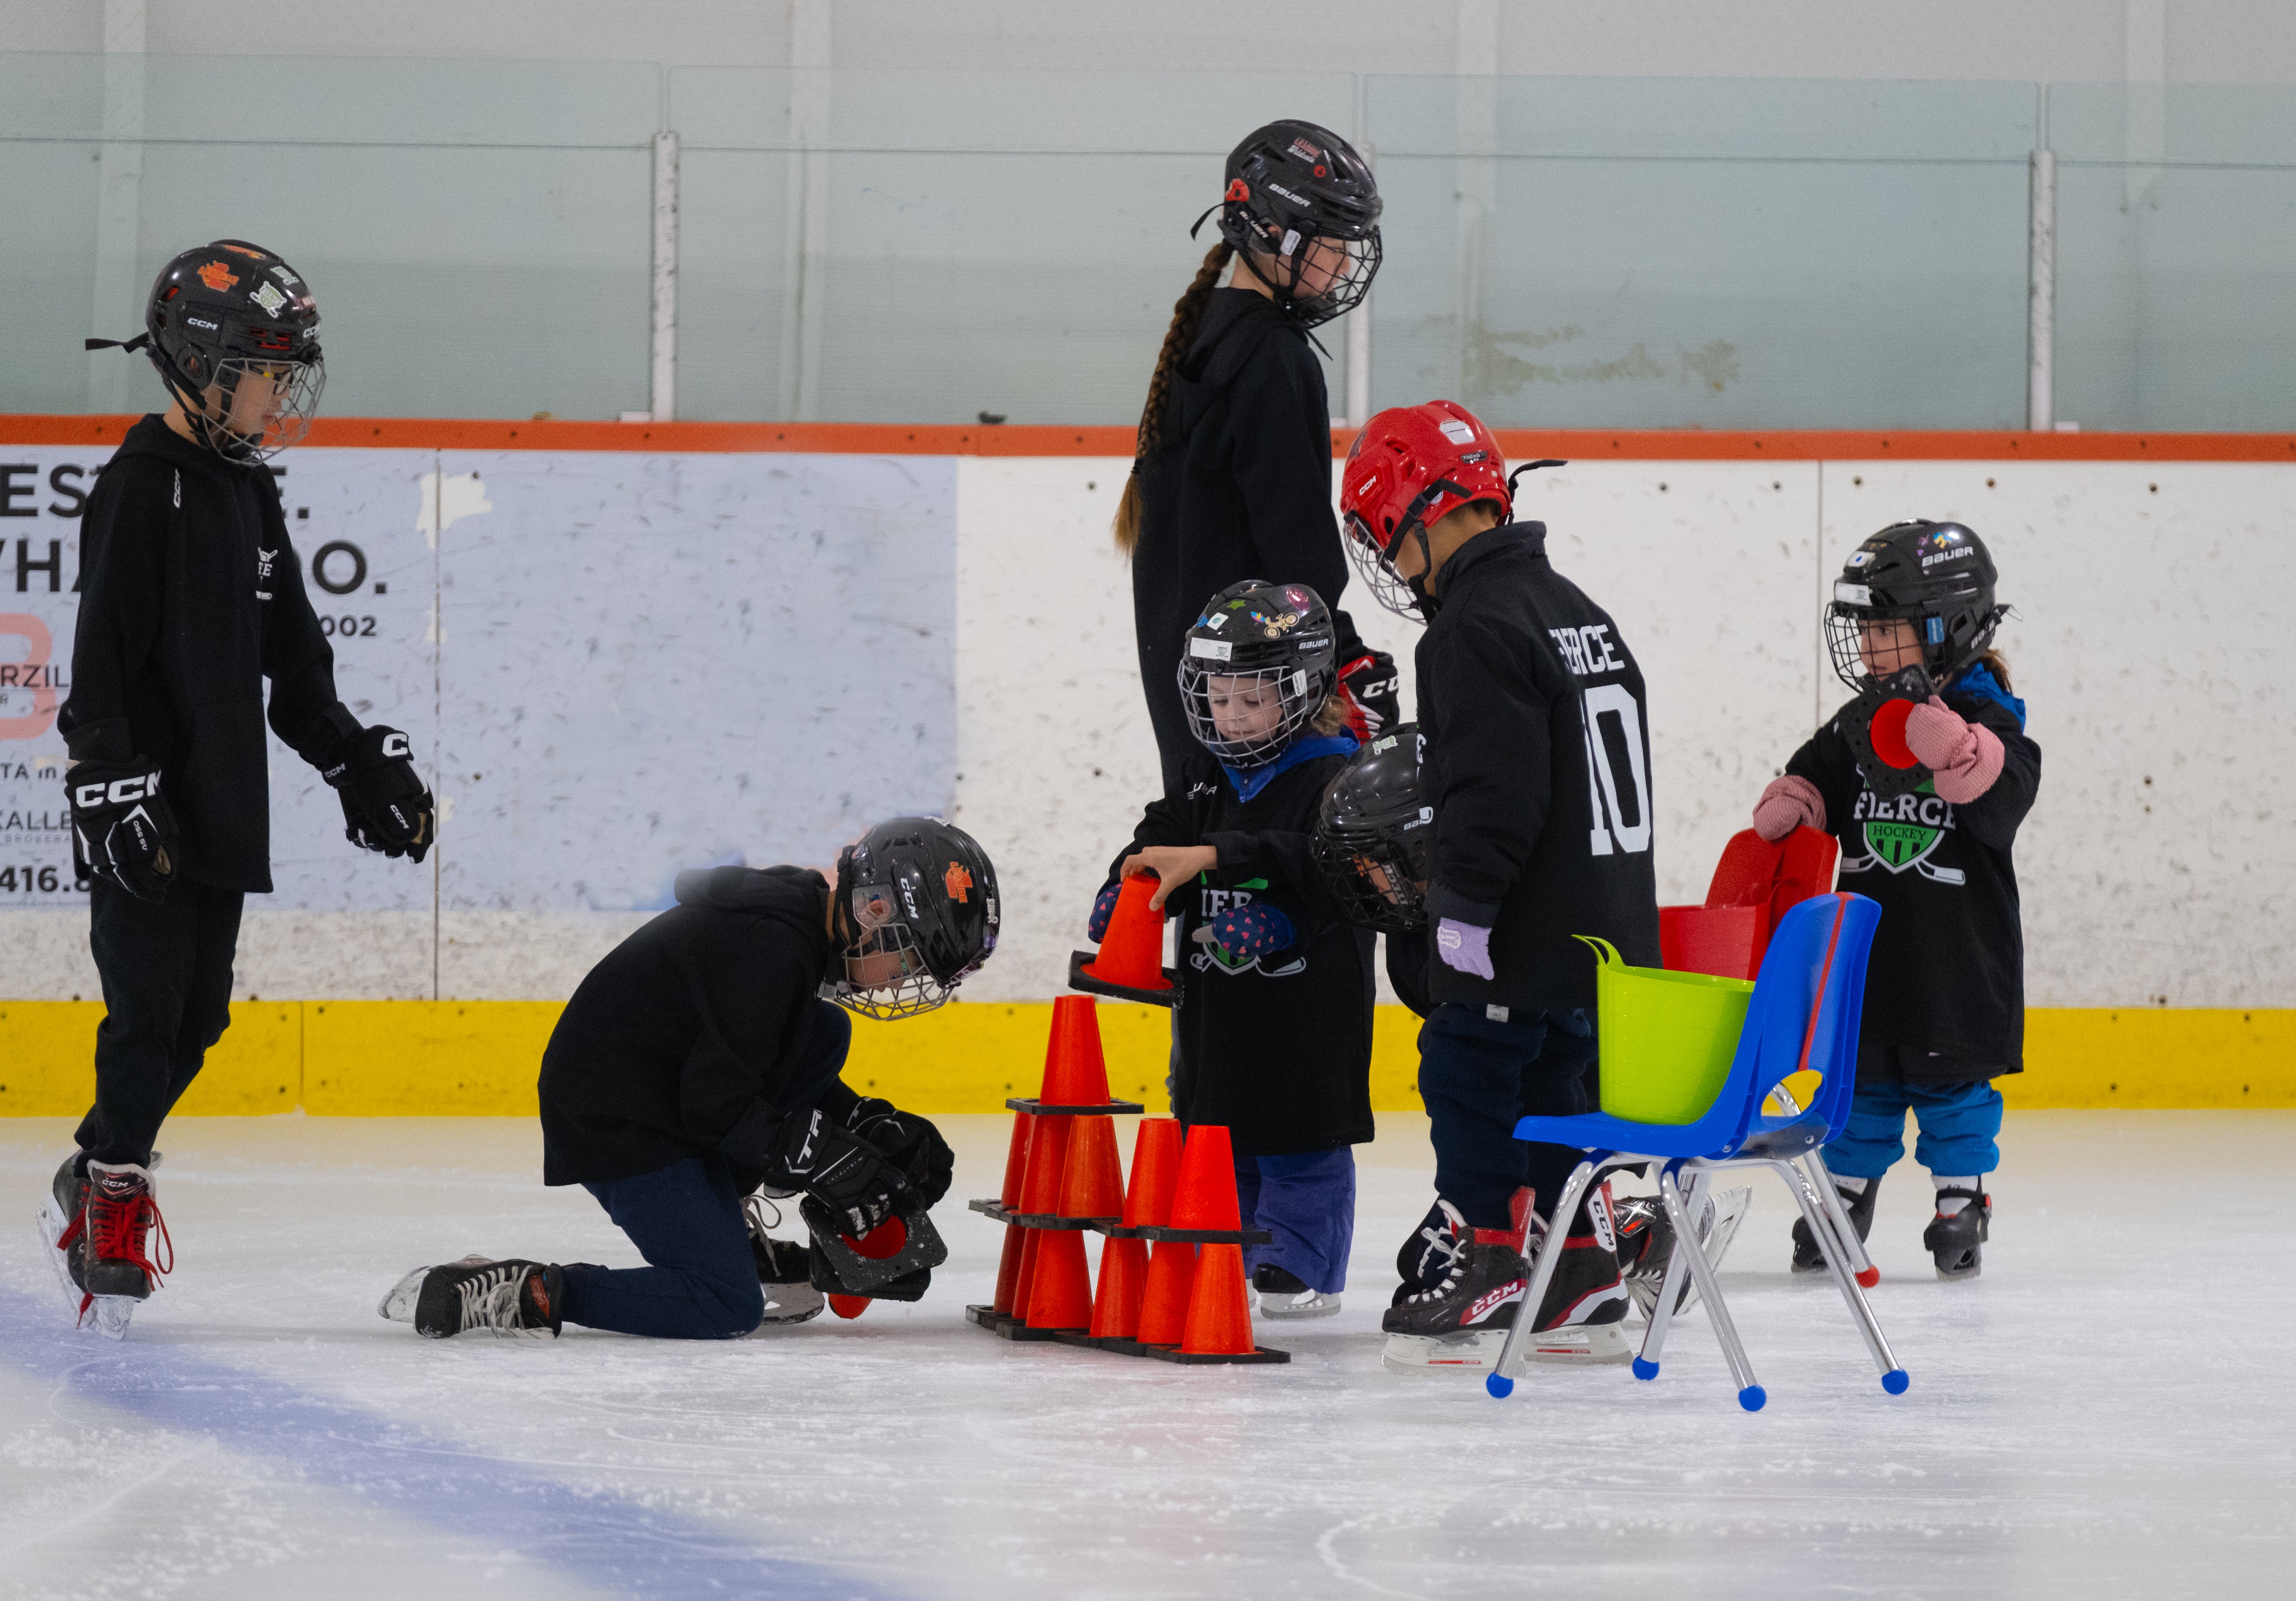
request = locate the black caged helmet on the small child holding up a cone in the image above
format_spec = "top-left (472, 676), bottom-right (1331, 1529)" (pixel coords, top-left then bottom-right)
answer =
top-left (1180, 579), bottom-right (1339, 772)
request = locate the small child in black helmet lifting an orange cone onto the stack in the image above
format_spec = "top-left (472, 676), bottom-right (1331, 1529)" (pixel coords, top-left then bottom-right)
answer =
top-left (1088, 579), bottom-right (1373, 1319)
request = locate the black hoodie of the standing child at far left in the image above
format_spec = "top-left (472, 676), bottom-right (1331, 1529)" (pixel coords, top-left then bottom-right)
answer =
top-left (55, 414), bottom-right (349, 891)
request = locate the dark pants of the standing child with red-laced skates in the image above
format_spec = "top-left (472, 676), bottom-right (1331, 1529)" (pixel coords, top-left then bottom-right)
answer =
top-left (73, 878), bottom-right (246, 1167)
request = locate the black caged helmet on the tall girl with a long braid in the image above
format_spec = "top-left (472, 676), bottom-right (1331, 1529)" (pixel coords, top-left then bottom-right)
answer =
top-left (1189, 122), bottom-right (1380, 328)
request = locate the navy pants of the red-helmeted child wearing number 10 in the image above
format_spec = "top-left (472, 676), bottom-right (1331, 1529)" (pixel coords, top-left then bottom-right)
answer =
top-left (1419, 1001), bottom-right (1598, 1229)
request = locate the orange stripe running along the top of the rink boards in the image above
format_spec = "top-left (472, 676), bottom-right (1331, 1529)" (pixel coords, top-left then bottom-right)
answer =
top-left (0, 414), bottom-right (2296, 462)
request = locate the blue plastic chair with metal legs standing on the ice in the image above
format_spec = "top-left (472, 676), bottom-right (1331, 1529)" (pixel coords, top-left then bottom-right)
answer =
top-left (1483, 894), bottom-right (1910, 1412)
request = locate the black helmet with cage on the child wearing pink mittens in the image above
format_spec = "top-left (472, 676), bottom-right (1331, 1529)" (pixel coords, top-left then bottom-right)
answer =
top-left (1825, 521), bottom-right (2009, 691)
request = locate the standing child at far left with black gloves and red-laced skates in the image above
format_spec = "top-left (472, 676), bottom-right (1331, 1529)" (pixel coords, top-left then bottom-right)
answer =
top-left (41, 239), bottom-right (434, 1337)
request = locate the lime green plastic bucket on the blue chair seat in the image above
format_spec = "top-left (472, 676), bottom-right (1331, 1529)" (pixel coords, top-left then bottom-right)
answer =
top-left (1577, 935), bottom-right (1754, 1123)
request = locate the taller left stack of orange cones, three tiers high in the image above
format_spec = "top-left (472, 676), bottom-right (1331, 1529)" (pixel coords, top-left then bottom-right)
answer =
top-left (964, 994), bottom-right (1141, 1339)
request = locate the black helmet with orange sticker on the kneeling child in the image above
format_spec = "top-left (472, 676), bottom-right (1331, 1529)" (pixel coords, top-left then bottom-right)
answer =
top-left (829, 818), bottom-right (996, 1018)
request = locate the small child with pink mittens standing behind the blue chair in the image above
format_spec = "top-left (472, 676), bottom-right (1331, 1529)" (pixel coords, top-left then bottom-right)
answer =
top-left (1754, 521), bottom-right (2041, 1279)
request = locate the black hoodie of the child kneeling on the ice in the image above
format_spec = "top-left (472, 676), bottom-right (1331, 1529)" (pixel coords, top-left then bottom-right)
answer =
top-left (542, 866), bottom-right (859, 1190)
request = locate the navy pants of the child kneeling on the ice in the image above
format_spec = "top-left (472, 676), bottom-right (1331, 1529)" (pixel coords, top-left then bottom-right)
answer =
top-left (565, 1155), bottom-right (764, 1339)
